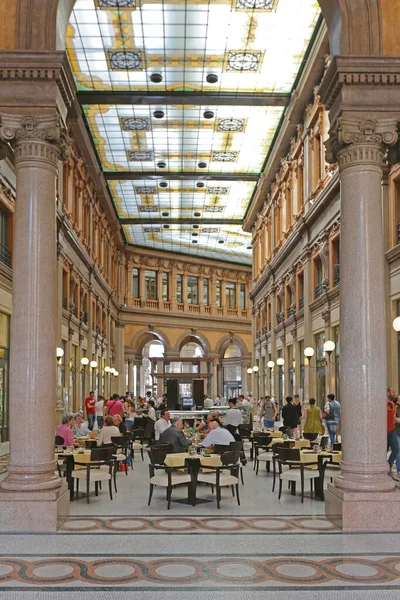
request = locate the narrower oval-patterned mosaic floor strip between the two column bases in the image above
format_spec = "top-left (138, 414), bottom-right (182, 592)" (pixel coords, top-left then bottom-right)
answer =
top-left (60, 515), bottom-right (339, 535)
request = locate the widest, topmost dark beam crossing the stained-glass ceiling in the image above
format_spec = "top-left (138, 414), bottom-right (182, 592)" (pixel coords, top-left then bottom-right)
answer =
top-left (77, 91), bottom-right (290, 106)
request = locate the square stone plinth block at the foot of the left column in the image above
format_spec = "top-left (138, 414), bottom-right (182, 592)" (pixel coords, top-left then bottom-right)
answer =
top-left (0, 483), bottom-right (69, 533)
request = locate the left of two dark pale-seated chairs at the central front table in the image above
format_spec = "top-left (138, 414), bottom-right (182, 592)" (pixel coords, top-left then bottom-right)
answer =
top-left (147, 444), bottom-right (192, 510)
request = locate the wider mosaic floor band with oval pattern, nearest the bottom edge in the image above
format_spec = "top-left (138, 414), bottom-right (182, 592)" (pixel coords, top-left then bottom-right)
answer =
top-left (0, 553), bottom-right (400, 591)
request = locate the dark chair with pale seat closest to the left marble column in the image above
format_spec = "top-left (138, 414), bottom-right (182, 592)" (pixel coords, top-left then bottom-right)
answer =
top-left (71, 446), bottom-right (115, 504)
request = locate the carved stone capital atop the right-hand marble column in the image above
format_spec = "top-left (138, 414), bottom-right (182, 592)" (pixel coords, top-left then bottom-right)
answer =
top-left (325, 117), bottom-right (398, 170)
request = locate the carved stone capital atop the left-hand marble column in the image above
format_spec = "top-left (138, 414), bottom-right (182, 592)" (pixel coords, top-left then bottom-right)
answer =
top-left (0, 114), bottom-right (71, 165)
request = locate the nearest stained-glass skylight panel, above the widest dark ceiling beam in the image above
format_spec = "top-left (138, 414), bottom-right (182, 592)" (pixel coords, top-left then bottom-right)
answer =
top-left (67, 0), bottom-right (320, 92)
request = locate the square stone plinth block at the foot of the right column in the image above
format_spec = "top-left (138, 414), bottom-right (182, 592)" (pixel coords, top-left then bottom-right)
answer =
top-left (325, 485), bottom-right (400, 532)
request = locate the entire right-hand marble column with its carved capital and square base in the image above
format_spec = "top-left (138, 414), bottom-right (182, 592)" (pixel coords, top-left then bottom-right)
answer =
top-left (326, 117), bottom-right (400, 531)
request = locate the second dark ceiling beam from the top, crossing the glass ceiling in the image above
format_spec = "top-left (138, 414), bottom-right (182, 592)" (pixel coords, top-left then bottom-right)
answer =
top-left (103, 171), bottom-right (259, 181)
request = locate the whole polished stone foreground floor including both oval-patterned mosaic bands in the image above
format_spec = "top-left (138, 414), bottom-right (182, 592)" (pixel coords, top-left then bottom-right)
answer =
top-left (0, 457), bottom-right (400, 600)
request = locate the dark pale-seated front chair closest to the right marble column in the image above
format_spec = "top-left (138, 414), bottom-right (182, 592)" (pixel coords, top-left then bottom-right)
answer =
top-left (277, 447), bottom-right (320, 503)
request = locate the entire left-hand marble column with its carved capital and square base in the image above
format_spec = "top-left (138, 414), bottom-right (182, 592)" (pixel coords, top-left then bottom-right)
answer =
top-left (0, 114), bottom-right (69, 531)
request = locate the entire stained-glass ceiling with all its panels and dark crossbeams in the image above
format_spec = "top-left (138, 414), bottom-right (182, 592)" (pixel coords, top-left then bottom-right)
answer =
top-left (67, 0), bottom-right (319, 264)
